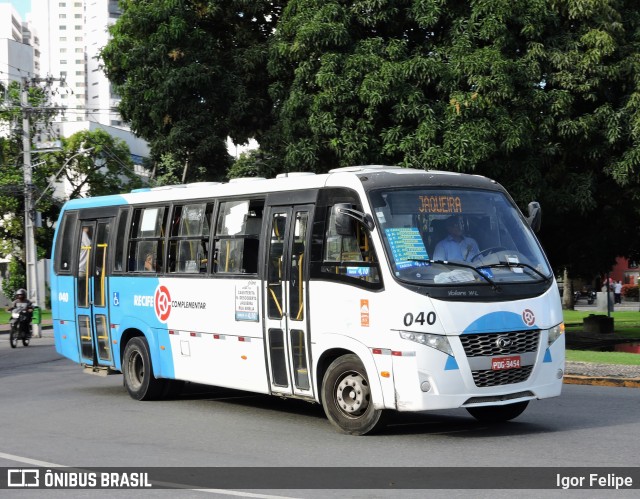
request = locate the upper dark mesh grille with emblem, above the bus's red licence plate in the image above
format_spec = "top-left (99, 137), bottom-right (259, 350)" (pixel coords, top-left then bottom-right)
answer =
top-left (460, 330), bottom-right (540, 357)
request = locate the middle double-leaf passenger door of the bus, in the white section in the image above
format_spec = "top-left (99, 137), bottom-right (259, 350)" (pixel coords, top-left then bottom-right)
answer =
top-left (264, 205), bottom-right (313, 396)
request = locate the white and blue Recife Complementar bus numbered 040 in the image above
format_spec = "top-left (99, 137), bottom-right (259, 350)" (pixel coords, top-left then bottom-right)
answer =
top-left (51, 166), bottom-right (565, 435)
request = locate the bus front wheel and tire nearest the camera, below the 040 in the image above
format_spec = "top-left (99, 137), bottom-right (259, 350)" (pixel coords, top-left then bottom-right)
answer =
top-left (322, 354), bottom-right (386, 435)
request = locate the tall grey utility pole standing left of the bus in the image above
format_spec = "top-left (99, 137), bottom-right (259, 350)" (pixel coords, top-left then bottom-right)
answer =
top-left (21, 78), bottom-right (42, 338)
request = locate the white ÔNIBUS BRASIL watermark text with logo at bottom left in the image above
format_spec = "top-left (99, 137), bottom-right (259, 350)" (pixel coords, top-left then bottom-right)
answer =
top-left (7, 468), bottom-right (153, 489)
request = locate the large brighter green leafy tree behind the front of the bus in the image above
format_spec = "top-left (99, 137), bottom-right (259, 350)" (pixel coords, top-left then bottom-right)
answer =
top-left (261, 0), bottom-right (640, 274)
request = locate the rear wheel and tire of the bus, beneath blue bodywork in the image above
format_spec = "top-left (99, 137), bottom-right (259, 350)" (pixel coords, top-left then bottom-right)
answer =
top-left (122, 336), bottom-right (165, 400)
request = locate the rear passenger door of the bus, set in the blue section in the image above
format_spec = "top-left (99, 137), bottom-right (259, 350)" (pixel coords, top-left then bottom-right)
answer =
top-left (76, 218), bottom-right (114, 367)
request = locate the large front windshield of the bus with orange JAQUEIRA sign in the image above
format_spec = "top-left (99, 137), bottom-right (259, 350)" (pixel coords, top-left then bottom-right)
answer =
top-left (371, 187), bottom-right (552, 286)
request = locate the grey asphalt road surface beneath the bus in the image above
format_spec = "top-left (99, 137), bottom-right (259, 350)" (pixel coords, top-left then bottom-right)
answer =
top-left (0, 333), bottom-right (640, 499)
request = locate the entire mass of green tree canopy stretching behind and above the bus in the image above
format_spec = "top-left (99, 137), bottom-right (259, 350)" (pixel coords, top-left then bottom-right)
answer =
top-left (103, 0), bottom-right (640, 275)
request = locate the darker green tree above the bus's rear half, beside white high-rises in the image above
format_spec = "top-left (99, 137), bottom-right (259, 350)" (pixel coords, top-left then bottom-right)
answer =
top-left (101, 0), bottom-right (281, 181)
